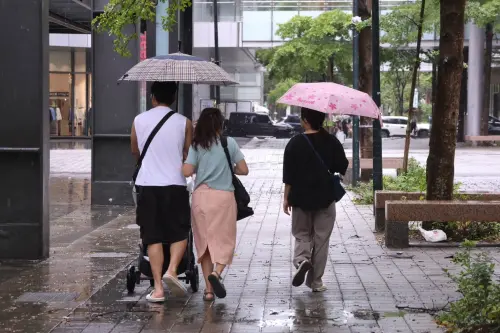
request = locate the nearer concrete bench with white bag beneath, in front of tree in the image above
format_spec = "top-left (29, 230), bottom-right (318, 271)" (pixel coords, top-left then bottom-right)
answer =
top-left (385, 200), bottom-right (500, 248)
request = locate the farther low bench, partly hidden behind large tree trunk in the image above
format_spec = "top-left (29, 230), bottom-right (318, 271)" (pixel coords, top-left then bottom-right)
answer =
top-left (375, 191), bottom-right (500, 232)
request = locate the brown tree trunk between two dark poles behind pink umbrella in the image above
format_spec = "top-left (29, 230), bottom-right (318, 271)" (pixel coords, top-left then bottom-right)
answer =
top-left (357, 0), bottom-right (373, 181)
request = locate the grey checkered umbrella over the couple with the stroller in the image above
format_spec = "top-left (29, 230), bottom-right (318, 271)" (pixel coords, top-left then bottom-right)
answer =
top-left (119, 53), bottom-right (238, 86)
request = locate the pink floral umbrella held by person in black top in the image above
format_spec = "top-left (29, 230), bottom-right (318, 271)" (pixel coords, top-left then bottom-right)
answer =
top-left (278, 82), bottom-right (381, 119)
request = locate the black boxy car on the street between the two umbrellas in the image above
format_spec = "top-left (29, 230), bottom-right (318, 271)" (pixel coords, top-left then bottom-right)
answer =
top-left (226, 112), bottom-right (293, 138)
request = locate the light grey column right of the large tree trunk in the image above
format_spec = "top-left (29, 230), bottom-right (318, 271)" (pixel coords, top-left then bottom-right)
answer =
top-left (466, 23), bottom-right (484, 135)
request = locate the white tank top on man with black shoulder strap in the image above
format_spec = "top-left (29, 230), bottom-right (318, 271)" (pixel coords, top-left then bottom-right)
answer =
top-left (134, 106), bottom-right (187, 186)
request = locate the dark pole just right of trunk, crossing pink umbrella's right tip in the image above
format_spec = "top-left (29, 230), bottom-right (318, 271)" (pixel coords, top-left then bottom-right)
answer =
top-left (372, 0), bottom-right (384, 191)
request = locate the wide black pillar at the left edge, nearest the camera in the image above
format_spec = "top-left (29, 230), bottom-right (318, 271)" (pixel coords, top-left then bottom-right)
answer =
top-left (0, 0), bottom-right (50, 260)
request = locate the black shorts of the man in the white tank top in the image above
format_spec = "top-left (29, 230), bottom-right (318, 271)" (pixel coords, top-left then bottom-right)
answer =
top-left (136, 186), bottom-right (191, 245)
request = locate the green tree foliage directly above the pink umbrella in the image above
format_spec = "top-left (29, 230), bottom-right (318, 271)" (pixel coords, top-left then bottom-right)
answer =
top-left (259, 10), bottom-right (352, 82)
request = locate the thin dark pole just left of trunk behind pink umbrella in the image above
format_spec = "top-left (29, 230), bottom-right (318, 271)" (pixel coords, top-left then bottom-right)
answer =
top-left (352, 0), bottom-right (359, 186)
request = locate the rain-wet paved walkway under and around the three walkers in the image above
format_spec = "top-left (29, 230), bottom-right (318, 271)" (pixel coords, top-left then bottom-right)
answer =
top-left (0, 140), bottom-right (500, 333)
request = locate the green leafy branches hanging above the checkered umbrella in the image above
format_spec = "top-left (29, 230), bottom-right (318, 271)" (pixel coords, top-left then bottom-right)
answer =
top-left (92, 0), bottom-right (191, 57)
